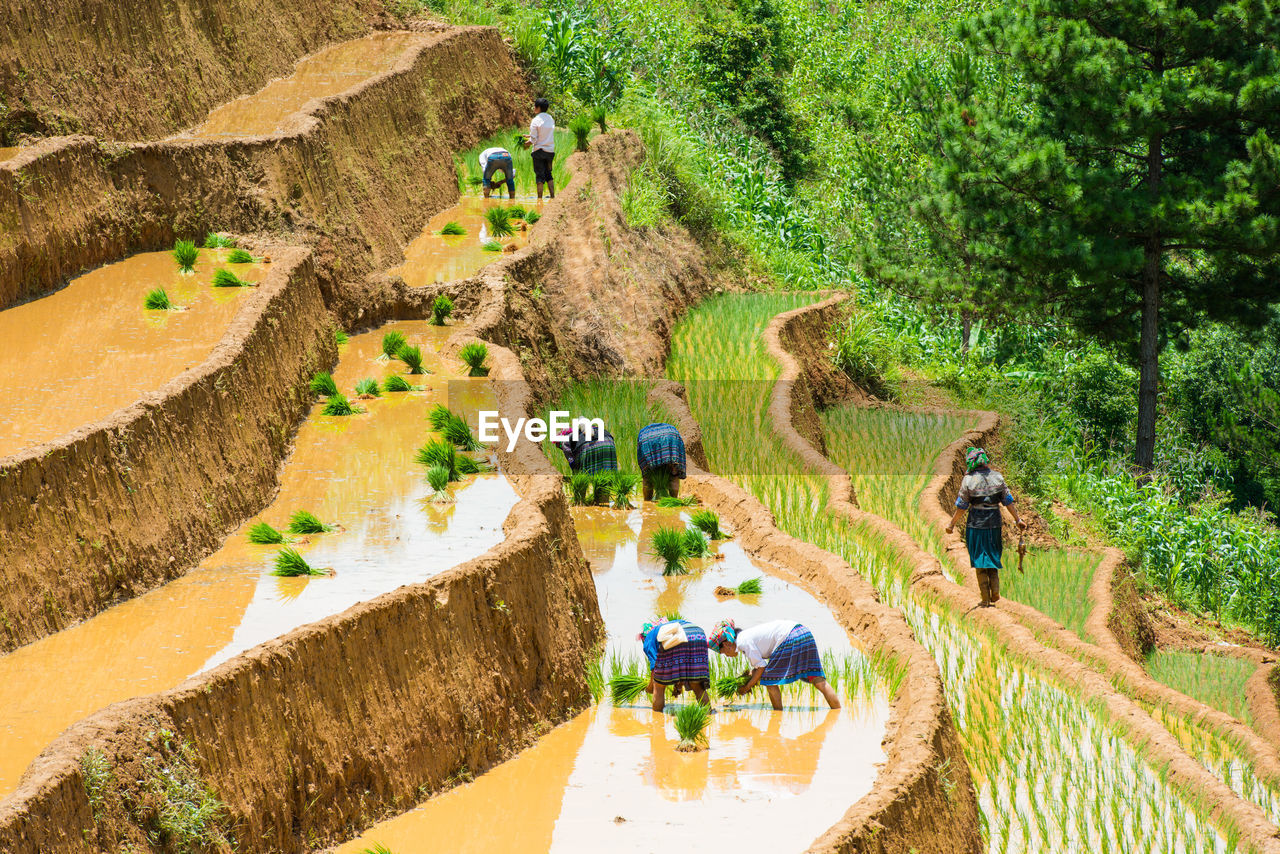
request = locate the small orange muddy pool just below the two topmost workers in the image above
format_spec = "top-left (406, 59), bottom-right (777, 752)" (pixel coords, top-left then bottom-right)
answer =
top-left (392, 196), bottom-right (540, 288)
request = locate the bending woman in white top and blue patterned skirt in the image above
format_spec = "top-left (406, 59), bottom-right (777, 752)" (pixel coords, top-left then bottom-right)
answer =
top-left (707, 620), bottom-right (840, 712)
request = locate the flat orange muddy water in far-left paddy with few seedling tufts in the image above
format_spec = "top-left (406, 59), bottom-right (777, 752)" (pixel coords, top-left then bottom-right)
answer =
top-left (0, 250), bottom-right (269, 457)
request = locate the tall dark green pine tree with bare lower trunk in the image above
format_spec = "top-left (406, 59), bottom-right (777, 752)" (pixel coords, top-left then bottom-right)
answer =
top-left (938, 0), bottom-right (1280, 471)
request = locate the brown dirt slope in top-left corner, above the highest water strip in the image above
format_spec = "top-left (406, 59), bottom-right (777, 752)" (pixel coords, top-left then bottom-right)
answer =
top-left (0, 0), bottom-right (384, 145)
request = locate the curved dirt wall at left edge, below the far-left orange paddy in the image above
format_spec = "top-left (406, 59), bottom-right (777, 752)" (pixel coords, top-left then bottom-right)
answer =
top-left (0, 248), bottom-right (335, 649)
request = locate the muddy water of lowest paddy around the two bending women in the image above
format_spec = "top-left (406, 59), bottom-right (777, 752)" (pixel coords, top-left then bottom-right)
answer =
top-left (338, 504), bottom-right (888, 854)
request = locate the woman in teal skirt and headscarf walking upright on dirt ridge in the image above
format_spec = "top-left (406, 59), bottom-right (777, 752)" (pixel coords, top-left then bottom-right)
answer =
top-left (947, 448), bottom-right (1027, 608)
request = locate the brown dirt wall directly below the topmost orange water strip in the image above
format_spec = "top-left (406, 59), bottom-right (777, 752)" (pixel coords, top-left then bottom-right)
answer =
top-left (0, 27), bottom-right (530, 309)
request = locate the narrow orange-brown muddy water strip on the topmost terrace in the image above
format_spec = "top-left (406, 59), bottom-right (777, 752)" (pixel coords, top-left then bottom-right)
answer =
top-left (179, 32), bottom-right (430, 140)
